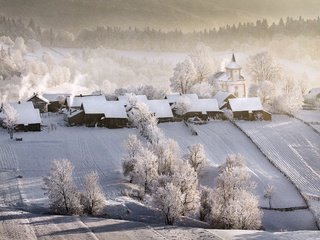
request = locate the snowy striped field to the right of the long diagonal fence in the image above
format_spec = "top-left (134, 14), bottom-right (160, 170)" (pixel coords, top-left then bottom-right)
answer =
top-left (236, 116), bottom-right (320, 226)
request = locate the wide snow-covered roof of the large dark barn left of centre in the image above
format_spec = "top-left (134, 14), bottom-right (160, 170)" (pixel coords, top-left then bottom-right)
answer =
top-left (83, 98), bottom-right (127, 118)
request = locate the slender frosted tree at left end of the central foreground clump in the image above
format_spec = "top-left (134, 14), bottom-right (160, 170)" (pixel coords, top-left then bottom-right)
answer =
top-left (122, 134), bottom-right (143, 182)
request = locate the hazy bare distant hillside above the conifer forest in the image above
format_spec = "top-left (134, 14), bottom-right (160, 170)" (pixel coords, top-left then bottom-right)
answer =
top-left (0, 0), bottom-right (320, 31)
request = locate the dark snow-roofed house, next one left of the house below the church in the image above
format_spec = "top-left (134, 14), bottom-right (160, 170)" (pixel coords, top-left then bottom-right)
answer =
top-left (184, 99), bottom-right (223, 121)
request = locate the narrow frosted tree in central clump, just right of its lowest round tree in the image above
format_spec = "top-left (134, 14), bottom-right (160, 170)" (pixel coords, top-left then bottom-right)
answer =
top-left (172, 161), bottom-right (200, 216)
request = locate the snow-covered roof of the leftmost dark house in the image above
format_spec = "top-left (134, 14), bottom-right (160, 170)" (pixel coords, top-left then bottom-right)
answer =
top-left (3, 102), bottom-right (41, 125)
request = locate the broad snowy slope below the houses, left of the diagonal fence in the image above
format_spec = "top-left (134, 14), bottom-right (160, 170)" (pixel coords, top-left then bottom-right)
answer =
top-left (0, 115), bottom-right (319, 230)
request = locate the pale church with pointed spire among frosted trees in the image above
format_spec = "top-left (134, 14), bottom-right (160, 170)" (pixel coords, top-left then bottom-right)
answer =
top-left (210, 53), bottom-right (247, 97)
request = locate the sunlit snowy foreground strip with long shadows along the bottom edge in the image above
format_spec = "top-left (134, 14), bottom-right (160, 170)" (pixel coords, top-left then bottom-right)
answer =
top-left (0, 209), bottom-right (319, 240)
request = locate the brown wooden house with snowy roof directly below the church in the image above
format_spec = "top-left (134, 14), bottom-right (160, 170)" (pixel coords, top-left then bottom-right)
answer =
top-left (227, 97), bottom-right (272, 121)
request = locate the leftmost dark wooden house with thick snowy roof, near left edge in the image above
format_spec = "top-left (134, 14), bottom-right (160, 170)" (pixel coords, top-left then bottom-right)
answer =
top-left (0, 102), bottom-right (41, 131)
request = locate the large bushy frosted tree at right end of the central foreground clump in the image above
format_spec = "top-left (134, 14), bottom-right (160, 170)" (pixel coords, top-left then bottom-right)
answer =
top-left (210, 155), bottom-right (262, 229)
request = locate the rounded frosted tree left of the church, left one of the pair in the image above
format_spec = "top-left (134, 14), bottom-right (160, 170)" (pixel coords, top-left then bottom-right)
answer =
top-left (170, 57), bottom-right (197, 94)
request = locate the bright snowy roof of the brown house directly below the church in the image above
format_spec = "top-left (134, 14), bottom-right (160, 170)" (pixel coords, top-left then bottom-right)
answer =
top-left (229, 97), bottom-right (263, 112)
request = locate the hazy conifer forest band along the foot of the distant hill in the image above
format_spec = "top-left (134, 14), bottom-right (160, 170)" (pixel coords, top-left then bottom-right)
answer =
top-left (0, 16), bottom-right (320, 51)
